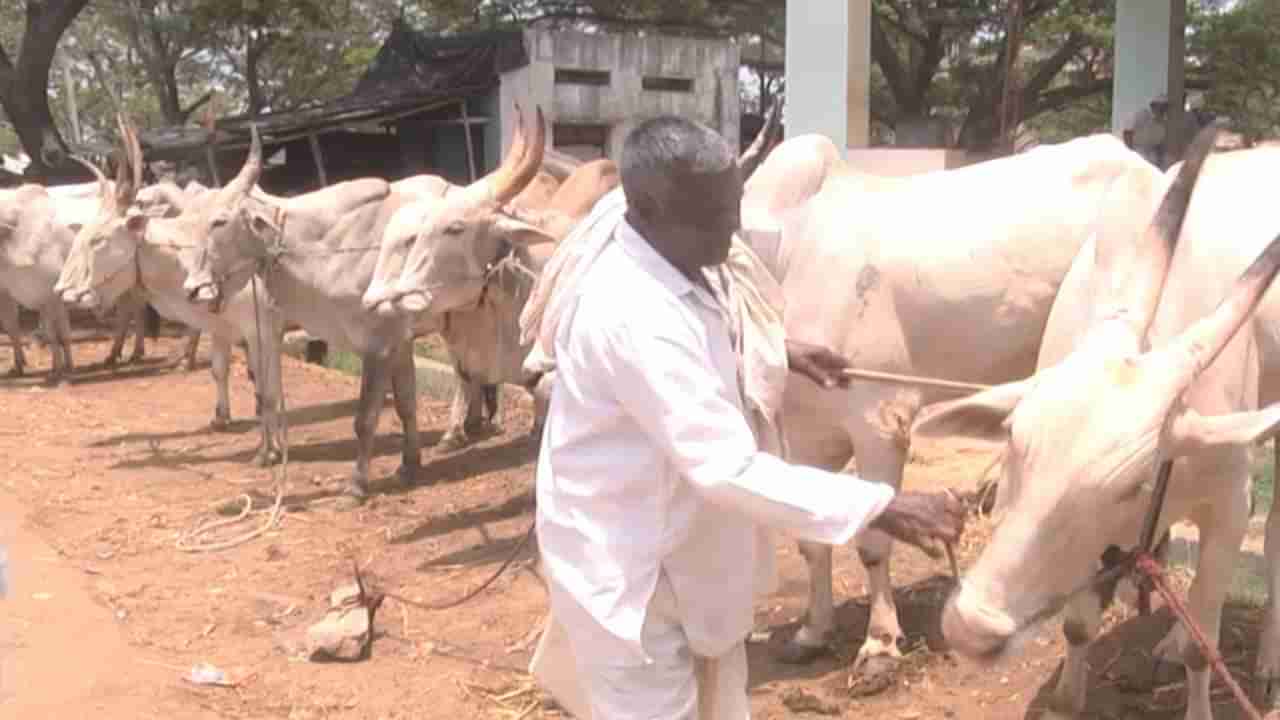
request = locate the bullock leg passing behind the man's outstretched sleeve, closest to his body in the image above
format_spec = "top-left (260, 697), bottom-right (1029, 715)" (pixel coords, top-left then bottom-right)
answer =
top-left (778, 421), bottom-right (854, 664)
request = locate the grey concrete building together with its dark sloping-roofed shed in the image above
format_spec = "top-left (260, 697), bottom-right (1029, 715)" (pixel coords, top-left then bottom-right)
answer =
top-left (129, 22), bottom-right (741, 193)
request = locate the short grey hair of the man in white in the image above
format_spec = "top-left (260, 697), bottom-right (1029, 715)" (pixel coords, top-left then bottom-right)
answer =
top-left (618, 115), bottom-right (737, 209)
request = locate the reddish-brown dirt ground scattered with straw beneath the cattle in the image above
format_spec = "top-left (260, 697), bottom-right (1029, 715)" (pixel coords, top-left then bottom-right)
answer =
top-left (0, 326), bottom-right (1260, 720)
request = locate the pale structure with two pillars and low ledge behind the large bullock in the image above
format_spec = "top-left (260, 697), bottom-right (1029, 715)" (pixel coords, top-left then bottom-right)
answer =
top-left (783, 0), bottom-right (1188, 174)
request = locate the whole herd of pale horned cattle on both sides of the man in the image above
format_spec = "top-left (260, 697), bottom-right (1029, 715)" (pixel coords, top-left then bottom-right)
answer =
top-left (0, 106), bottom-right (1280, 720)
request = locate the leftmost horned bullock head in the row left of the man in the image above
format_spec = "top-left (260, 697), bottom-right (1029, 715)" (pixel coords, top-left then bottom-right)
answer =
top-left (54, 117), bottom-right (147, 309)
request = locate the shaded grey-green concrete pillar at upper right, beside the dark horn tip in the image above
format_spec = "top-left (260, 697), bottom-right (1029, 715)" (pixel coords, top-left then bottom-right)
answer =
top-left (1111, 0), bottom-right (1187, 155)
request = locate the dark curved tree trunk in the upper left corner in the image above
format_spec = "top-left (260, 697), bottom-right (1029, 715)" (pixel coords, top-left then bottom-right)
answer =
top-left (0, 0), bottom-right (88, 177)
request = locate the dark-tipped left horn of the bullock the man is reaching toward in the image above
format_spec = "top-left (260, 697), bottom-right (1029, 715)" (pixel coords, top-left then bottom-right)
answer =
top-left (1096, 126), bottom-right (1217, 345)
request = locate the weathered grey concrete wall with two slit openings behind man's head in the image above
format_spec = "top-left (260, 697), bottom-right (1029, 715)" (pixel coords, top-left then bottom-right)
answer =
top-left (488, 29), bottom-right (740, 168)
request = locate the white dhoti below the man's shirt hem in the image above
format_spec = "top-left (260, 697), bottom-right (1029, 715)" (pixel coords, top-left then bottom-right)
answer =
top-left (529, 568), bottom-right (751, 720)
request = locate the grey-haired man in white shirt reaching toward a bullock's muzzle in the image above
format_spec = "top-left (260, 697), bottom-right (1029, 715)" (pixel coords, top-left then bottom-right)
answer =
top-left (536, 117), bottom-right (964, 720)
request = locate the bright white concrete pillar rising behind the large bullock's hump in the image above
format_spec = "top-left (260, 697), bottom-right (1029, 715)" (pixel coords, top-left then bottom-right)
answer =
top-left (783, 0), bottom-right (872, 147)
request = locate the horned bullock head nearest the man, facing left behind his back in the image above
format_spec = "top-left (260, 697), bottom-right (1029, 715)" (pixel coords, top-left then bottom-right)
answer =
top-left (364, 104), bottom-right (554, 314)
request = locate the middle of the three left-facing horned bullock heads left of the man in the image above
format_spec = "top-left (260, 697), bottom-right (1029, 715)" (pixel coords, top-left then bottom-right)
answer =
top-left (183, 124), bottom-right (267, 305)
